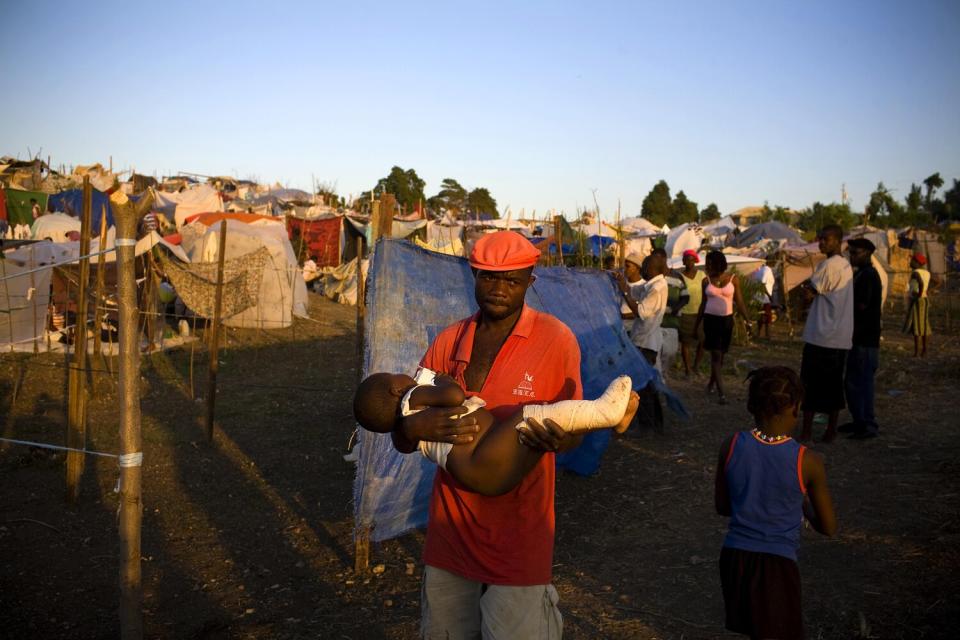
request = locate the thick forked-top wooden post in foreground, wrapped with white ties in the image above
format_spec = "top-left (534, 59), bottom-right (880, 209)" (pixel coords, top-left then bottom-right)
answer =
top-left (115, 188), bottom-right (143, 640)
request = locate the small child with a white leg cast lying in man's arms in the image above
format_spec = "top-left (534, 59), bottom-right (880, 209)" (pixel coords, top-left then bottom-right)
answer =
top-left (353, 368), bottom-right (640, 496)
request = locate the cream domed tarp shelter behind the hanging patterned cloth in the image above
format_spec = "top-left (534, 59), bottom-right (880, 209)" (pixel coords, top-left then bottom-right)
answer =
top-left (174, 213), bottom-right (307, 329)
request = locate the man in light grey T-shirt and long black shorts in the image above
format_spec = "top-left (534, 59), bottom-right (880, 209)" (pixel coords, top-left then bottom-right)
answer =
top-left (800, 225), bottom-right (853, 442)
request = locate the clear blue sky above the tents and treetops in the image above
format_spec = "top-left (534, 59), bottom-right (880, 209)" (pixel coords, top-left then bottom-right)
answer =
top-left (0, 0), bottom-right (960, 217)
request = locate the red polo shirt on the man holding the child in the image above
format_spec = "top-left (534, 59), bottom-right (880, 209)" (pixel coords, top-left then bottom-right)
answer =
top-left (421, 306), bottom-right (583, 586)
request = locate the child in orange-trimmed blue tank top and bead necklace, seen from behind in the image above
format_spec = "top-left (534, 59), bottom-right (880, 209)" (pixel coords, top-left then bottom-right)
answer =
top-left (714, 367), bottom-right (837, 639)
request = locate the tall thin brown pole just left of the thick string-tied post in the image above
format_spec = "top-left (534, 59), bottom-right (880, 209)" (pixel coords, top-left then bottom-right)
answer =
top-left (67, 176), bottom-right (93, 502)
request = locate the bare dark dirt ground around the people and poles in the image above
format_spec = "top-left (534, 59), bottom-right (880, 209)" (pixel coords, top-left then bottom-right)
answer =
top-left (0, 294), bottom-right (960, 640)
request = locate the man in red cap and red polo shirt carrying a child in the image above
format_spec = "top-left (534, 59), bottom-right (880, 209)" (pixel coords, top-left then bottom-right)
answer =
top-left (393, 231), bottom-right (583, 640)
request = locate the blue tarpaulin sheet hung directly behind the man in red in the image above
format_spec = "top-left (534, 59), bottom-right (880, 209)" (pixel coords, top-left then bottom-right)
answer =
top-left (354, 239), bottom-right (682, 541)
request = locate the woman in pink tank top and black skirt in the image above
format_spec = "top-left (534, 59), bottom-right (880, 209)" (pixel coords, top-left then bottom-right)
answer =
top-left (695, 251), bottom-right (753, 404)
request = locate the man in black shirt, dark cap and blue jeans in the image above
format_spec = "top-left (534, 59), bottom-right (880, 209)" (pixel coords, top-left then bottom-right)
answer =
top-left (837, 238), bottom-right (883, 440)
